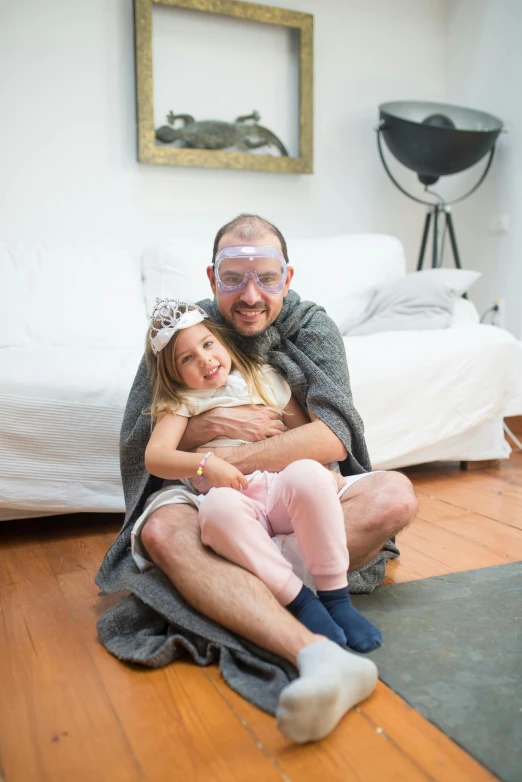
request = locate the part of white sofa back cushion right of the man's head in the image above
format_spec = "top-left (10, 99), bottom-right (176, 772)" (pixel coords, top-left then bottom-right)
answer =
top-left (288, 234), bottom-right (406, 325)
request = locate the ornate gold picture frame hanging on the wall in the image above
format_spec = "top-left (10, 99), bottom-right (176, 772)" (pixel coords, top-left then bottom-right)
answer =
top-left (134, 0), bottom-right (313, 174)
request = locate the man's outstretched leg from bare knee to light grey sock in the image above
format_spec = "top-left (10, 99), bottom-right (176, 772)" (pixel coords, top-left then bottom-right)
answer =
top-left (141, 504), bottom-right (377, 743)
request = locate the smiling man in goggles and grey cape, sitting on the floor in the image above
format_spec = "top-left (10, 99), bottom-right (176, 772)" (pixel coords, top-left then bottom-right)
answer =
top-left (97, 215), bottom-right (417, 741)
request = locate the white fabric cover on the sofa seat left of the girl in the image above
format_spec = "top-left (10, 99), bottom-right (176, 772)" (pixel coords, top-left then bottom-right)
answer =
top-left (0, 347), bottom-right (142, 520)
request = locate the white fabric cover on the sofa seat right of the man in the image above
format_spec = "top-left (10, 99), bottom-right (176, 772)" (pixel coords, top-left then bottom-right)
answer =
top-left (344, 325), bottom-right (522, 469)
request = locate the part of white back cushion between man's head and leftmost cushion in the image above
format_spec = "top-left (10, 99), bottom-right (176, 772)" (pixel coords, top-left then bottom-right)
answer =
top-left (141, 239), bottom-right (212, 315)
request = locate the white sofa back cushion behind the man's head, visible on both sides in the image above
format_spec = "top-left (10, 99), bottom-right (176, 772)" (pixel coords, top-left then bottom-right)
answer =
top-left (142, 234), bottom-right (406, 323)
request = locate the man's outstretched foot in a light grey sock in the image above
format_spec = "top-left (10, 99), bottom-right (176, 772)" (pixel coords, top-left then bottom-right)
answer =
top-left (276, 641), bottom-right (377, 744)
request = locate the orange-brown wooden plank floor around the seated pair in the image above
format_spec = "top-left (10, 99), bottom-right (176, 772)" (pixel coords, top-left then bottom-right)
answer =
top-left (0, 454), bottom-right (522, 782)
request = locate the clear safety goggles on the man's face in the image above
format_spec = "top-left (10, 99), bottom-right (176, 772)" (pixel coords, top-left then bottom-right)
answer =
top-left (214, 245), bottom-right (288, 293)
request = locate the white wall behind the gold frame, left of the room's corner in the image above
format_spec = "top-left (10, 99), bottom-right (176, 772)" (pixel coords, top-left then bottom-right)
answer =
top-left (0, 0), bottom-right (446, 264)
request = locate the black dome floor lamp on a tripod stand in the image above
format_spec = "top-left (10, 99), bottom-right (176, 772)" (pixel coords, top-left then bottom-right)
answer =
top-left (375, 101), bottom-right (503, 271)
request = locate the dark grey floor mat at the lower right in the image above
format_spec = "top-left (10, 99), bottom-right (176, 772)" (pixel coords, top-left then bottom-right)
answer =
top-left (353, 562), bottom-right (522, 782)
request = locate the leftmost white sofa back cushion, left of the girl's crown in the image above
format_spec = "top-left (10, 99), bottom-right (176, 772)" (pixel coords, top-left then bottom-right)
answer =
top-left (0, 243), bottom-right (147, 347)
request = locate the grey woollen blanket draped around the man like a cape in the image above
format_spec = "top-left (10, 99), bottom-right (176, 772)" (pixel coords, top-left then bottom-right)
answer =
top-left (96, 291), bottom-right (399, 714)
